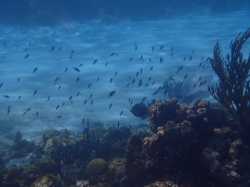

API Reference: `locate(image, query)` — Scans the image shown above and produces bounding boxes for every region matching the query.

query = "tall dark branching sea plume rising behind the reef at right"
[208,28,250,129]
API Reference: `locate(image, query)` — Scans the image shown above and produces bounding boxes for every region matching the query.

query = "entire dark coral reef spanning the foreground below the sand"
[0,98,250,187]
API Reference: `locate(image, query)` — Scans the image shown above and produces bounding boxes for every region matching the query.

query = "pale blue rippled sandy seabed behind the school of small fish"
[0,12,250,143]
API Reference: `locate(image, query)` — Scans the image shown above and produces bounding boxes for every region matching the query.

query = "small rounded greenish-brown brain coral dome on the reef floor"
[86,158,108,176]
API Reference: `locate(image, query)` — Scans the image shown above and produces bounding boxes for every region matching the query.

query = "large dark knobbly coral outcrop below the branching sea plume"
[126,98,250,186]
